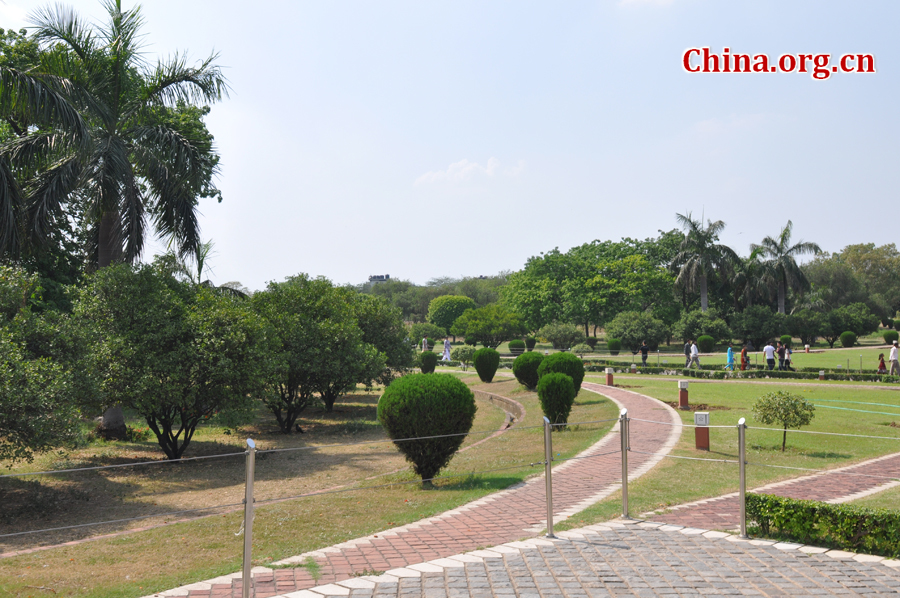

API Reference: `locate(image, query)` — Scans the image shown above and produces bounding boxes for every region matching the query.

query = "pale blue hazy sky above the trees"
[0,0,900,290]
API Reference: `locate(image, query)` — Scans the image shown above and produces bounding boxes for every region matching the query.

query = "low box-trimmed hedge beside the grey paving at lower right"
[746,494,900,558]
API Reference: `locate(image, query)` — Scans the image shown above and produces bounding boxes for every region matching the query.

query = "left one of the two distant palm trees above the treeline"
[672,212,740,311]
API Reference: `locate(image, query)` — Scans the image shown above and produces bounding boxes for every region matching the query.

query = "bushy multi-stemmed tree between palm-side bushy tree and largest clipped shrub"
[251,274,384,422]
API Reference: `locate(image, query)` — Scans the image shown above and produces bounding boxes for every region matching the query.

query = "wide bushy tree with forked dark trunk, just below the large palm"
[74,265,268,459]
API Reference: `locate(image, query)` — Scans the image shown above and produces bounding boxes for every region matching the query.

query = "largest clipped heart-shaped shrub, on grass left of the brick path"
[378,374,476,486]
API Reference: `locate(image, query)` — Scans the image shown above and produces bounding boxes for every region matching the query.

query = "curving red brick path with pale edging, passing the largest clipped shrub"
[149,383,681,598]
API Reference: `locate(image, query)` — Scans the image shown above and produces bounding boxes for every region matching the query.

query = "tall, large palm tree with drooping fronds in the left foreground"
[0,0,228,267]
